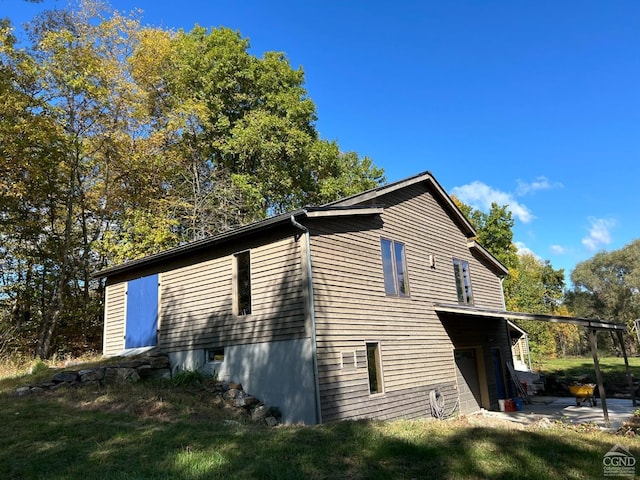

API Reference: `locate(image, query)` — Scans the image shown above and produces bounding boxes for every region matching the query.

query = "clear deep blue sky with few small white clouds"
[0,0,640,282]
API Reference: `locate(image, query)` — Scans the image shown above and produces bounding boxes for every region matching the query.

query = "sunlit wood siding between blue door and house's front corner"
[159,237,307,352]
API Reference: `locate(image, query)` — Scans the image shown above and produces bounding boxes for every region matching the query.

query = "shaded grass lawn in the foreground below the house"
[0,358,640,480]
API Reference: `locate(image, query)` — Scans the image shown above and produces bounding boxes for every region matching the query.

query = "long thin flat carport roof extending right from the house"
[434,303,627,332]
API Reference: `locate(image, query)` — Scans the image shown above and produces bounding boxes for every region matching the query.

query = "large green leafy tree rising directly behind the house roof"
[133,26,384,241]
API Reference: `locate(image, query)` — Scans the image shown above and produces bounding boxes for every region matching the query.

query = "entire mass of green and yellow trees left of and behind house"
[0,0,384,357]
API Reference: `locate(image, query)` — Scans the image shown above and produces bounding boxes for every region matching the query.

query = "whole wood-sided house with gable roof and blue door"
[97,172,524,424]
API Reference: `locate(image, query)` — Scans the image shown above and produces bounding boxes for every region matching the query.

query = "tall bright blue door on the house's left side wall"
[124,275,158,348]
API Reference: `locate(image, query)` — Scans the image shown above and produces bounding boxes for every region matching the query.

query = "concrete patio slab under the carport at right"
[482,396,640,430]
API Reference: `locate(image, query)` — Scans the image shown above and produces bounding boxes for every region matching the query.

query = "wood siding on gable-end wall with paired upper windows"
[310,180,510,421]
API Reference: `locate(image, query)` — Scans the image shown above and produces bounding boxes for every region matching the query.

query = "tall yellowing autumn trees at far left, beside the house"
[0,2,151,357]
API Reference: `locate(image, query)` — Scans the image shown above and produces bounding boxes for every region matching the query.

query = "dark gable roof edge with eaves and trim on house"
[93,171,509,278]
